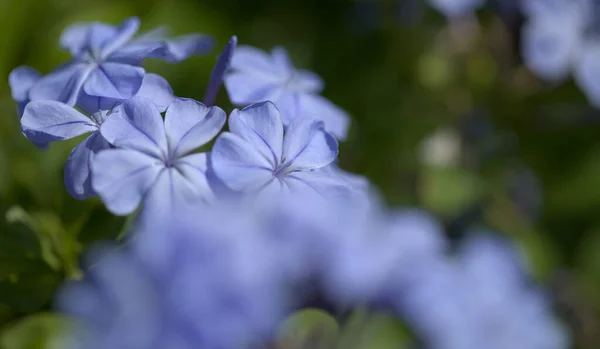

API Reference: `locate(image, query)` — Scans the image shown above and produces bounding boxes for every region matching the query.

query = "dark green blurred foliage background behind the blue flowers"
[0,0,600,348]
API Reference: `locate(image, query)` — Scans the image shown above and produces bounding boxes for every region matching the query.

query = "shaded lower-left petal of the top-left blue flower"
[29,62,94,105]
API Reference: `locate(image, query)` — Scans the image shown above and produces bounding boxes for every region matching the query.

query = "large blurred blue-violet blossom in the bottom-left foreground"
[56,207,289,349]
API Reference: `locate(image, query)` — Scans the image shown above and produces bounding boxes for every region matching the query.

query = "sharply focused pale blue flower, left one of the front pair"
[91,96,226,215]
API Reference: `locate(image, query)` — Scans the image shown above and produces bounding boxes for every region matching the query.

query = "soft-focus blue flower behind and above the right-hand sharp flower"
[225,46,350,140]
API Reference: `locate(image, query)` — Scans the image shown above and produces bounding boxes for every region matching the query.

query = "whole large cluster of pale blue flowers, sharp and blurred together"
[9,18,568,349]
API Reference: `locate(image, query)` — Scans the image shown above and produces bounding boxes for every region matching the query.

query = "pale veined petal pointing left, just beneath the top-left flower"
[21,101,98,143]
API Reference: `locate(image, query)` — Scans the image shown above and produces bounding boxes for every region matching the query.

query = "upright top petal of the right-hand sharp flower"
[229,102,283,168]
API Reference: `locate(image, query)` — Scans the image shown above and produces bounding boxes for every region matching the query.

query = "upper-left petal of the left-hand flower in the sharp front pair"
[100,96,168,159]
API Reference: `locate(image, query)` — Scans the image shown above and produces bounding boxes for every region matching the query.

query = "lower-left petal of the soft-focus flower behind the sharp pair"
[224,70,282,106]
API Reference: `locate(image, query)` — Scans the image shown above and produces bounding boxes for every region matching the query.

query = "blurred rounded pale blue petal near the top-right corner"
[521,19,581,80]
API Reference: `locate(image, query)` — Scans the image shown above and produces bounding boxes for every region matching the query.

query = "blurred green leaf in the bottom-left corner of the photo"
[0,313,72,349]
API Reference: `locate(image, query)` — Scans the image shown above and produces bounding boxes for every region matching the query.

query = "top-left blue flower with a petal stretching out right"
[23,17,213,106]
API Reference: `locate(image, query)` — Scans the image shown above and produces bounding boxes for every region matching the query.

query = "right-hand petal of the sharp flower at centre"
[283,118,338,171]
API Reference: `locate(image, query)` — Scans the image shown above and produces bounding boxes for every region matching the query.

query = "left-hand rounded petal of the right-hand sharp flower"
[210,132,273,191]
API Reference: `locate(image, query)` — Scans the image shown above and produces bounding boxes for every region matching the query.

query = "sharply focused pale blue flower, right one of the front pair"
[211,102,348,196]
